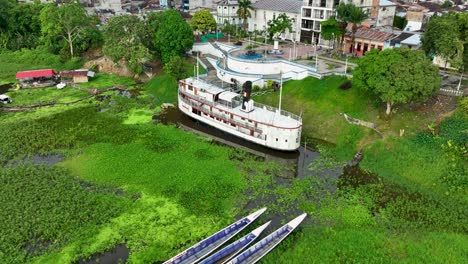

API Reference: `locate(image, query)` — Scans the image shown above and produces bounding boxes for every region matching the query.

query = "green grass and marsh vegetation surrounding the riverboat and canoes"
[0,50,468,264]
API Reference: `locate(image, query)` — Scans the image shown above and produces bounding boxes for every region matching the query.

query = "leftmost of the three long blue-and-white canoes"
[164,208,266,264]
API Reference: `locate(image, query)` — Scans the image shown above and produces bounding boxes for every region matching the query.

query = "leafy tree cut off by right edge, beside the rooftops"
[422,13,468,69]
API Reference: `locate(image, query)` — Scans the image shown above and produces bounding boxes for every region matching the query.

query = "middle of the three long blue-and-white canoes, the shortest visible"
[200,221,271,264]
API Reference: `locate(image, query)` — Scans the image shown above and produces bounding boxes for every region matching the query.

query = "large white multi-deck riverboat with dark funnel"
[178,77,302,151]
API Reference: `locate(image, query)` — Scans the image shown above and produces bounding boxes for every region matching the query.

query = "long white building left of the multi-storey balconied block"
[247,0,302,41]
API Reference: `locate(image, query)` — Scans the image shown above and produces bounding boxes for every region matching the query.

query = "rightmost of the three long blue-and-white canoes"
[228,213,307,264]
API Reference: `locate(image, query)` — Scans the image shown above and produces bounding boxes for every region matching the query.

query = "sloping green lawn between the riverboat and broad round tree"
[254,76,378,143]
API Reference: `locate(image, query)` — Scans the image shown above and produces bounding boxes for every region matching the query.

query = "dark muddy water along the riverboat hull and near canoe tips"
[153,108,342,234]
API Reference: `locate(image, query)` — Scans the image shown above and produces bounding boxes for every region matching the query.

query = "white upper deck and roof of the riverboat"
[179,78,302,129]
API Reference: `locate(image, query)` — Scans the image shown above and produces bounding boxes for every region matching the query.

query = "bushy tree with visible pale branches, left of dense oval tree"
[103,15,150,73]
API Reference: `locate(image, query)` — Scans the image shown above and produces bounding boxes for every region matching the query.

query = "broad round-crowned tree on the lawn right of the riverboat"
[353,48,441,115]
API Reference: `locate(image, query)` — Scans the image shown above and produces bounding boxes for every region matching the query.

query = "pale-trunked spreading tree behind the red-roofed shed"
[40,3,95,57]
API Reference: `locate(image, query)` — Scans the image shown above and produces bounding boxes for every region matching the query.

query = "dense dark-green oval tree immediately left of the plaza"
[154,9,193,63]
